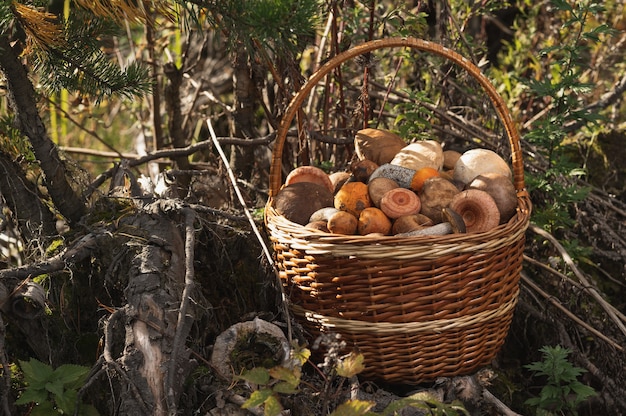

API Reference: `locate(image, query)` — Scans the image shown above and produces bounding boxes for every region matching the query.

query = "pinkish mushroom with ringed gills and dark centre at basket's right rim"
[449,189,500,233]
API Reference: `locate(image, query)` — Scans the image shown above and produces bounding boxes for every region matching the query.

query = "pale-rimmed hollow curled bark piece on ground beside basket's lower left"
[211,318,290,381]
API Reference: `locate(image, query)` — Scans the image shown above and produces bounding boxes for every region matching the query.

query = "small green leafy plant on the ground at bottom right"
[525,345,596,415]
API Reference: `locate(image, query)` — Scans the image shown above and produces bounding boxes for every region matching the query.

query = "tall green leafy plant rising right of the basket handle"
[522,0,614,232]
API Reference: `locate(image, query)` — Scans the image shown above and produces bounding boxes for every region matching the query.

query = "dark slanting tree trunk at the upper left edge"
[0,36,85,224]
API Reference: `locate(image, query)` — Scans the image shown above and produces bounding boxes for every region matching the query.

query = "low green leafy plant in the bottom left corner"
[15,358,98,416]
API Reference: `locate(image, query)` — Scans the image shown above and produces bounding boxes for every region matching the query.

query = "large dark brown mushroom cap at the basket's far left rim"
[273,182,333,225]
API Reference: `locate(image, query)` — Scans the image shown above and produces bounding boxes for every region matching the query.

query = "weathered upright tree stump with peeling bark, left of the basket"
[113,204,195,416]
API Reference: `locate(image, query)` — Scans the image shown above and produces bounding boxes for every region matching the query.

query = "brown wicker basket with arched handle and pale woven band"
[265,38,531,384]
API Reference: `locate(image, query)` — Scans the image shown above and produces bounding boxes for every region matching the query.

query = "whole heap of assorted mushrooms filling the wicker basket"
[274,128,517,236]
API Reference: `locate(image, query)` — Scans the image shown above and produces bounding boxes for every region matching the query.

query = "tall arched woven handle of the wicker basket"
[269,37,528,199]
